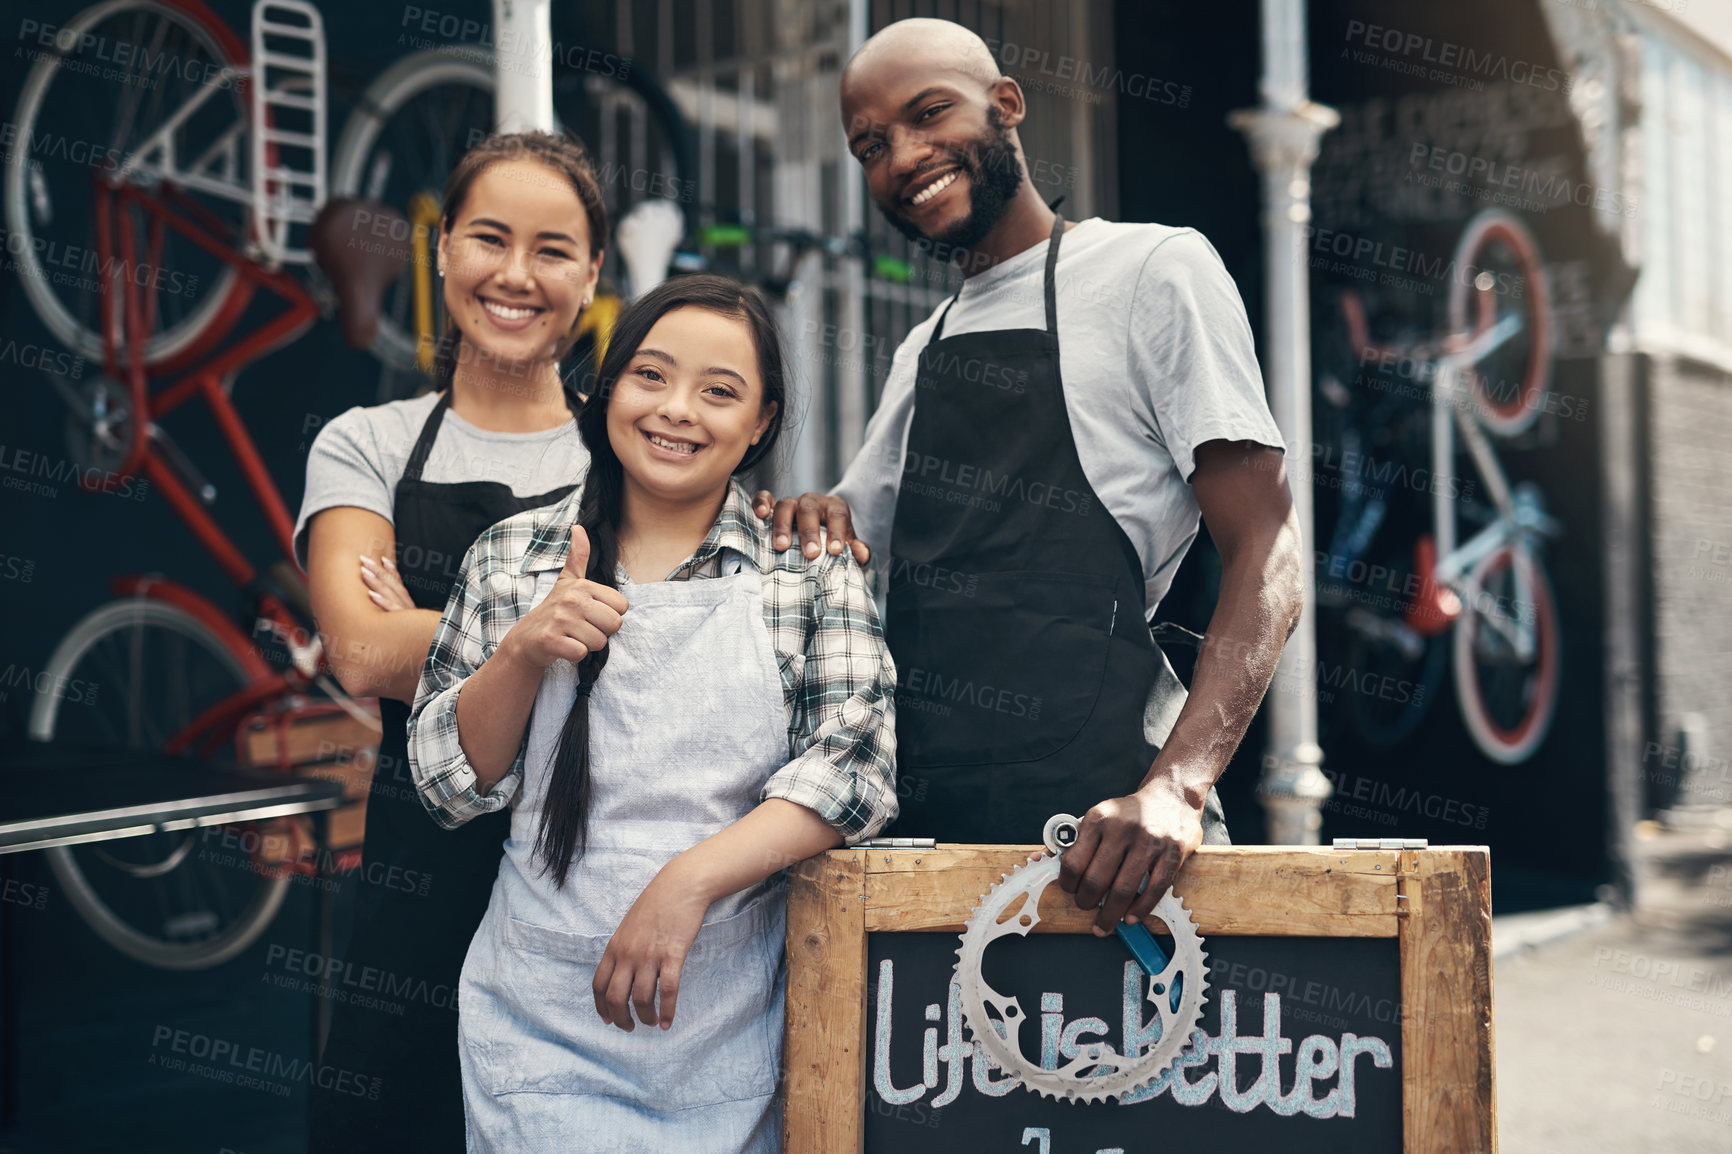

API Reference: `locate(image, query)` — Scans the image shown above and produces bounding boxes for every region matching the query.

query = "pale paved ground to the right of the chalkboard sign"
[1493,813,1732,1154]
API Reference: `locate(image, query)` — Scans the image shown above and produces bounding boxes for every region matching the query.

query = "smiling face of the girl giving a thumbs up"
[608,307,776,502]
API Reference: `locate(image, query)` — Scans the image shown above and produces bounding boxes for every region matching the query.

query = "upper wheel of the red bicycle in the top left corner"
[5,0,249,364]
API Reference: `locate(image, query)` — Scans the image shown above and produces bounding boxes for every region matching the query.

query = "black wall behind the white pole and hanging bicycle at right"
[1115,0,1628,908]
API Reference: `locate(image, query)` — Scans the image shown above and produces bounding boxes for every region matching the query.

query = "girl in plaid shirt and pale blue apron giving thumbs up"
[409,276,897,1152]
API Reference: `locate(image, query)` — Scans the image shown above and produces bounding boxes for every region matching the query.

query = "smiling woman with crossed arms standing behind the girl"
[296,133,608,1154]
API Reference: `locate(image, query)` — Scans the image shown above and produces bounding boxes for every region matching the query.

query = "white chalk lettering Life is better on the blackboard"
[873,958,1394,1118]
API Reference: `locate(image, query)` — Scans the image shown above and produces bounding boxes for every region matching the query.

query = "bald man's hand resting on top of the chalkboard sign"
[1058,778,1202,937]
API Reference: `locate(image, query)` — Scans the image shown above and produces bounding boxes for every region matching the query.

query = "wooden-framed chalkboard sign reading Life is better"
[785,846,1493,1154]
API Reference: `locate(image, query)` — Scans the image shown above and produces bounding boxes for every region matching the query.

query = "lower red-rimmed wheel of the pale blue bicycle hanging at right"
[1455,546,1561,766]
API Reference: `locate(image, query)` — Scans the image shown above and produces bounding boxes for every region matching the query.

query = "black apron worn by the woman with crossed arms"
[308,390,575,1154]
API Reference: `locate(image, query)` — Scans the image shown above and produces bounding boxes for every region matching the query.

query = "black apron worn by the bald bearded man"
[885,217,1228,844]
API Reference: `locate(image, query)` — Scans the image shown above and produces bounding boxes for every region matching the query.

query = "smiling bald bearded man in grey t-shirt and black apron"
[759,19,1302,934]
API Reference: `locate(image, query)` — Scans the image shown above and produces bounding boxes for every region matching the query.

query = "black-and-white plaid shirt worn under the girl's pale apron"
[409,482,897,846]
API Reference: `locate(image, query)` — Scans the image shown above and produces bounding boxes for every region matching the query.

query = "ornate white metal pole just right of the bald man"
[1228,0,1341,846]
